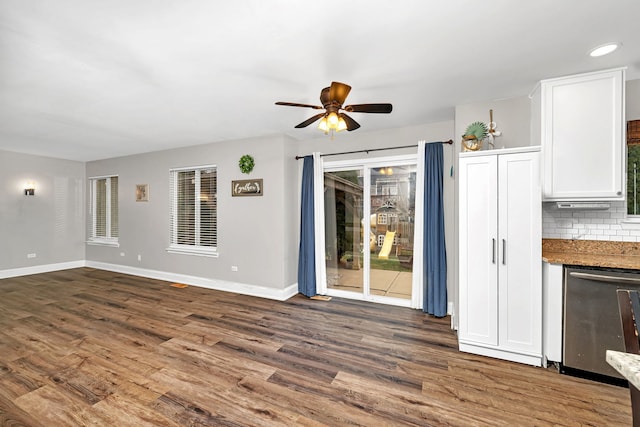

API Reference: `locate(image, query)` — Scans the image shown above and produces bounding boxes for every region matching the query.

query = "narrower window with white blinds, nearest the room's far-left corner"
[89,176,119,245]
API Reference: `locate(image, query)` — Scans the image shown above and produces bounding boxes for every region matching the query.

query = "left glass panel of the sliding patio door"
[324,169,364,294]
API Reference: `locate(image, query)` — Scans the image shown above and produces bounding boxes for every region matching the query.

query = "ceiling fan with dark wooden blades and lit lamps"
[276,82,393,133]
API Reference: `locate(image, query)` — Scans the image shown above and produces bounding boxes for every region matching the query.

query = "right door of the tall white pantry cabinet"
[498,153,542,356]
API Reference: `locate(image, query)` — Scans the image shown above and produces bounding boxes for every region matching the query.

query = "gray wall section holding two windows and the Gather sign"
[86,136,297,289]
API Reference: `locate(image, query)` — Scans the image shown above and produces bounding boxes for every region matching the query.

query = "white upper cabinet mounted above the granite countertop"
[532,68,626,201]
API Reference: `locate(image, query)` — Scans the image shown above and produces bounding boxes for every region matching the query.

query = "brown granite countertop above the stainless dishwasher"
[542,239,640,270]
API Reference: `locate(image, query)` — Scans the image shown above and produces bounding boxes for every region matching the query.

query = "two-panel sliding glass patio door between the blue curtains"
[324,162,416,306]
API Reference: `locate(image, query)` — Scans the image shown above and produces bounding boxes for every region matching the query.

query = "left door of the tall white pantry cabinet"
[458,156,498,346]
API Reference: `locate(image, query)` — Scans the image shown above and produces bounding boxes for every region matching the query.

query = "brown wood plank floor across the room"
[0,268,631,427]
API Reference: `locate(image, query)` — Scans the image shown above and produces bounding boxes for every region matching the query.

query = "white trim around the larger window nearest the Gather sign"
[166,164,220,258]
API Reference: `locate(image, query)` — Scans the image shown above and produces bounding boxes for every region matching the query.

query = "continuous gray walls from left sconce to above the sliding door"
[0,121,456,306]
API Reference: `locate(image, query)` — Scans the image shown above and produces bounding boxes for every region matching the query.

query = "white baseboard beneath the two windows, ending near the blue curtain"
[86,261,298,301]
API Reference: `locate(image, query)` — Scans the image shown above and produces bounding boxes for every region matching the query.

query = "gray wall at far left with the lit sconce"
[0,150,86,270]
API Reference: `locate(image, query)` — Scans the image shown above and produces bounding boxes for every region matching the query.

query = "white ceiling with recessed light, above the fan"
[0,0,640,161]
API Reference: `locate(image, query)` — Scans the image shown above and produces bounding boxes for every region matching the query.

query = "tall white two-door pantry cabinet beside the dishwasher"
[458,147,542,366]
